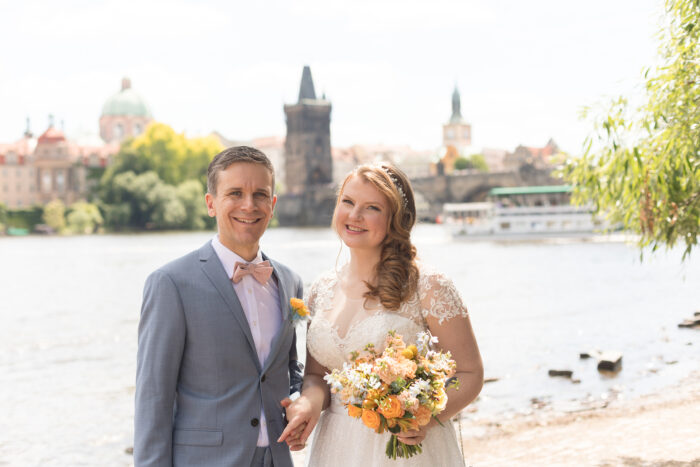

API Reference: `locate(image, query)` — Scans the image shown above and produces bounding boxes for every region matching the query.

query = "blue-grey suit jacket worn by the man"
[134,242,303,467]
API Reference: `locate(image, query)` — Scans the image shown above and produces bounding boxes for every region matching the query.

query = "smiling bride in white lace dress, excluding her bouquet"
[279,164,483,467]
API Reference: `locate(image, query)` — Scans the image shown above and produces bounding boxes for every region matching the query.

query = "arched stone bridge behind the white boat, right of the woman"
[411,165,562,219]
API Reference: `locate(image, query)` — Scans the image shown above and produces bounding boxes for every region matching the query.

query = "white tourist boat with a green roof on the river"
[442,185,607,238]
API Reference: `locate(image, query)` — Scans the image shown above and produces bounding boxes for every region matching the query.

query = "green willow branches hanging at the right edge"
[563,0,700,259]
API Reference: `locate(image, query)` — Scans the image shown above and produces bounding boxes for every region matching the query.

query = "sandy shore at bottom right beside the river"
[293,372,700,467]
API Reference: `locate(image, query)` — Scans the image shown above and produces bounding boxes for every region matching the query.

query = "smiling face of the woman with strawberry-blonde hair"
[334,175,390,254]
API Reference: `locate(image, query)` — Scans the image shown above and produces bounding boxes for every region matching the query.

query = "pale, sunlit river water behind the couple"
[0,225,700,466]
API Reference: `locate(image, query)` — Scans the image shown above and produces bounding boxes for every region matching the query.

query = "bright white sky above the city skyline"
[0,0,663,154]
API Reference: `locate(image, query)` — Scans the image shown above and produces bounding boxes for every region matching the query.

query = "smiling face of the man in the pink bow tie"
[206,162,277,261]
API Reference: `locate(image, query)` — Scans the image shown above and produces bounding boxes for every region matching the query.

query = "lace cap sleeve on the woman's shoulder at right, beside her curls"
[418,270,468,324]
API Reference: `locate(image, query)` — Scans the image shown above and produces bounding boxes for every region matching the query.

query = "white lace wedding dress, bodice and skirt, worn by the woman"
[306,265,467,467]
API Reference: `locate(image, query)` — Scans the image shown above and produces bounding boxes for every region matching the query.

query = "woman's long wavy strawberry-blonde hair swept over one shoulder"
[332,162,418,310]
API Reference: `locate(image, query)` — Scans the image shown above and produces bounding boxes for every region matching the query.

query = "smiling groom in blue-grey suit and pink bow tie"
[134,146,302,467]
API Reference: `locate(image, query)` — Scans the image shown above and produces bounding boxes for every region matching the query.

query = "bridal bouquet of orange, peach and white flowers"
[324,331,458,459]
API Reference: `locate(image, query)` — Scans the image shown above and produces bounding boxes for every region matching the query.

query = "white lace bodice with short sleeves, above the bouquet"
[306,264,467,370]
